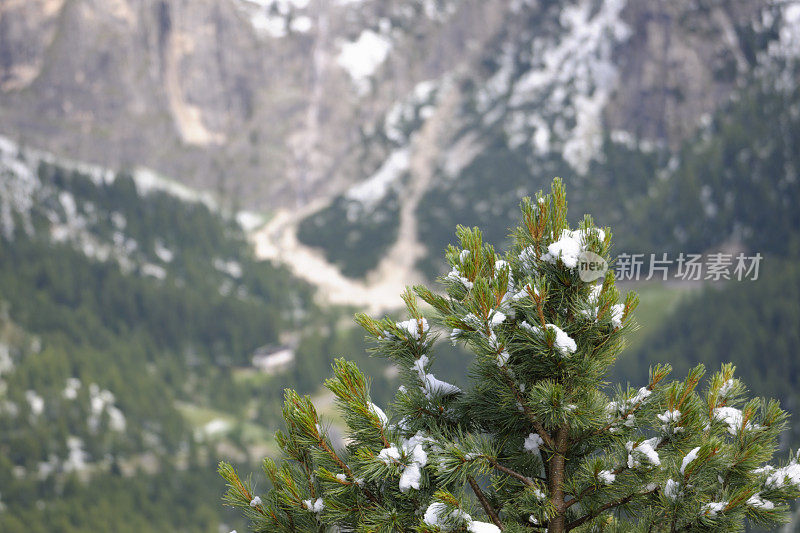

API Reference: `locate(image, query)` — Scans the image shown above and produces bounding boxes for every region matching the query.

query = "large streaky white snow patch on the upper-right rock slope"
[494,0,631,174]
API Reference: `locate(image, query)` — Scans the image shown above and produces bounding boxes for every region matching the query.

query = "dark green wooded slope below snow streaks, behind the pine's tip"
[416,130,664,278]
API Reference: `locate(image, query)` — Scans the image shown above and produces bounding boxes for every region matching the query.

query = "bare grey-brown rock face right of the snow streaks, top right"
[607,0,764,146]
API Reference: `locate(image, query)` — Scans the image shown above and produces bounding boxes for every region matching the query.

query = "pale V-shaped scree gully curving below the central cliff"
[253,86,457,313]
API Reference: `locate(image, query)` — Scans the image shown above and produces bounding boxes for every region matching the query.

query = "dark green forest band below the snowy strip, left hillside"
[0,239,288,364]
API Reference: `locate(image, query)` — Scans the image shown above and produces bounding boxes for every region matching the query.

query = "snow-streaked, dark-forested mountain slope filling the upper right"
[288,2,800,279]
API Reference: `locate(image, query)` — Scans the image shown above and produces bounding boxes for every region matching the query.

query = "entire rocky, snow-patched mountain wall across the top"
[0,0,800,288]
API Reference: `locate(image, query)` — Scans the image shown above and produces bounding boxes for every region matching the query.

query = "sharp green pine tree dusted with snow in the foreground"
[220,180,800,533]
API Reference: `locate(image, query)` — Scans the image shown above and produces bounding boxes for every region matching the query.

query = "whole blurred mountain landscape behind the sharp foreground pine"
[0,0,800,531]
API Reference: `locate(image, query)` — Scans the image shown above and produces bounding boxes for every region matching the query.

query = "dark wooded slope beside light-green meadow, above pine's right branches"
[615,256,800,440]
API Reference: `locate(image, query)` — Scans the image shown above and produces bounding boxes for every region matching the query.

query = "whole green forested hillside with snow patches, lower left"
[0,138,322,532]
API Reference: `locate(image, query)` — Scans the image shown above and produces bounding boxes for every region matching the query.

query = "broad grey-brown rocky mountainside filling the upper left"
[0,0,501,209]
